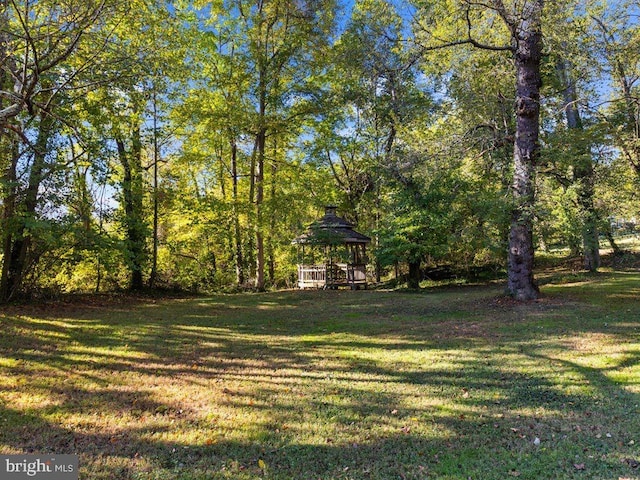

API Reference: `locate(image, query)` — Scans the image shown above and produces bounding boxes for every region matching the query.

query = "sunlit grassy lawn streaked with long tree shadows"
[0,271,640,480]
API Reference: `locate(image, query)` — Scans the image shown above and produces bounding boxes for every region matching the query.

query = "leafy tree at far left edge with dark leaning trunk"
[0,0,111,301]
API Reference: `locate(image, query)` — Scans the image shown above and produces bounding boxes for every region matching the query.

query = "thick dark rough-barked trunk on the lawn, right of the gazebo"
[507,0,543,300]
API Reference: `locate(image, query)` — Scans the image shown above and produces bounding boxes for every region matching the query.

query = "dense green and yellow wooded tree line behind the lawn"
[0,0,640,301]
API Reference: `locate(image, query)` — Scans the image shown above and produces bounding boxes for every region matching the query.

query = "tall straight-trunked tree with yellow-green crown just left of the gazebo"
[238,0,334,290]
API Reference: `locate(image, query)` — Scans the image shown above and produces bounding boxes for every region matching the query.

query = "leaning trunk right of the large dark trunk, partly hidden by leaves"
[557,60,600,272]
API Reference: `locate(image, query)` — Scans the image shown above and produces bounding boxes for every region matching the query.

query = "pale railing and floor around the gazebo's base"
[298,263,367,289]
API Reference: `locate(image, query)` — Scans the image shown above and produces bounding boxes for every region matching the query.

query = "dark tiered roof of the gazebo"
[291,206,371,245]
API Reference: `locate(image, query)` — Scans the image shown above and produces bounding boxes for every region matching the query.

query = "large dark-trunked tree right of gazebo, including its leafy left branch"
[417,0,544,300]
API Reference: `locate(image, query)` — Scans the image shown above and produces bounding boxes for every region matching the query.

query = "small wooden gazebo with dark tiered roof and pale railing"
[291,206,371,289]
